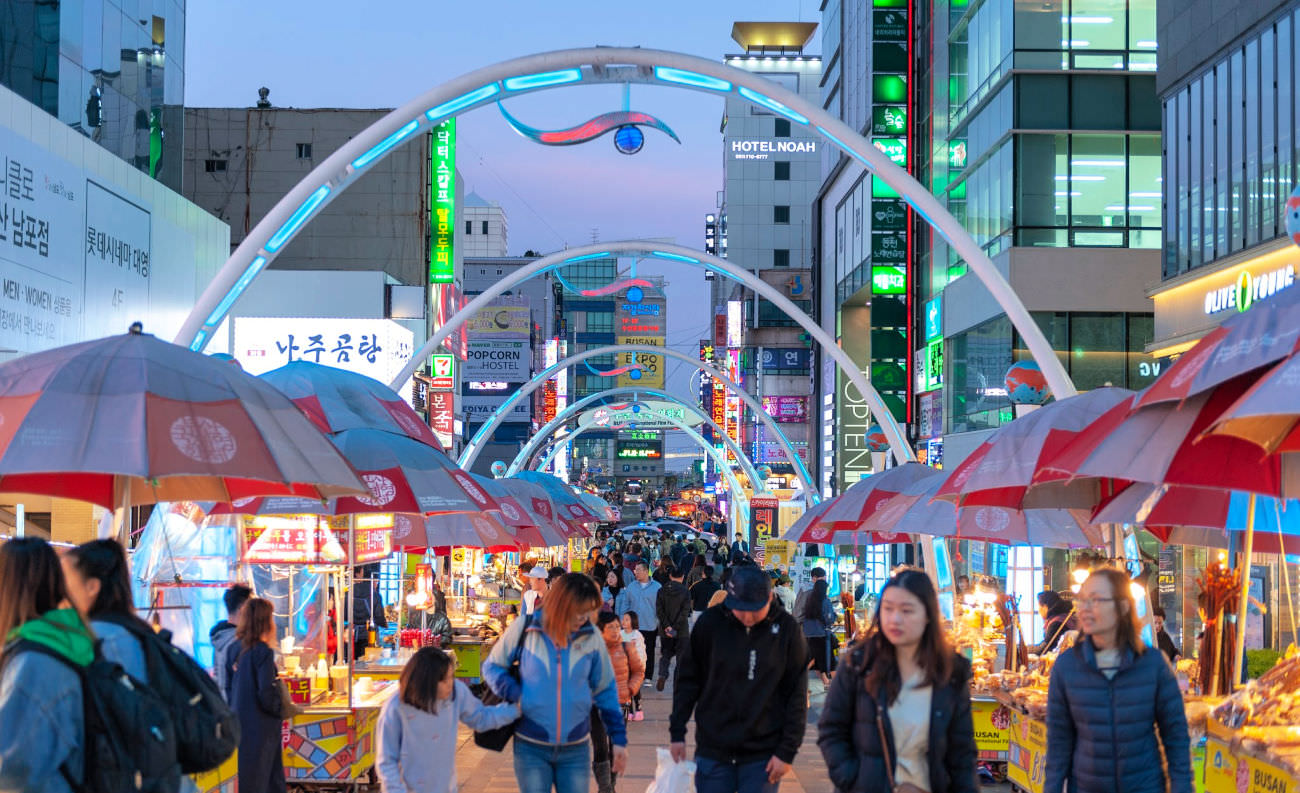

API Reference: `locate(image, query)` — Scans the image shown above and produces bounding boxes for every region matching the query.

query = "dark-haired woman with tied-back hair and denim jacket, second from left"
[62,540,152,683]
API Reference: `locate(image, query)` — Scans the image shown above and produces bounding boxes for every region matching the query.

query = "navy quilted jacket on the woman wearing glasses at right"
[1043,640,1192,793]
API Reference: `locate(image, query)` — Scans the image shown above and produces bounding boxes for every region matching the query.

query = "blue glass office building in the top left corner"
[0,0,185,191]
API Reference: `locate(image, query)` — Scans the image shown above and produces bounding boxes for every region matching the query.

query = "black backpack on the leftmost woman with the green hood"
[4,640,181,793]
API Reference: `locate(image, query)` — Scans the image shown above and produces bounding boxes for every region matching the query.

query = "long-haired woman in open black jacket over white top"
[818,568,977,793]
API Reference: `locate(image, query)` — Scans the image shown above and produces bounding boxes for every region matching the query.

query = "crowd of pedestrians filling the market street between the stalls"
[0,534,1192,793]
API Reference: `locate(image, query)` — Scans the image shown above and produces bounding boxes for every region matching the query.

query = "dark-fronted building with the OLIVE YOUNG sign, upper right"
[1151,0,1300,356]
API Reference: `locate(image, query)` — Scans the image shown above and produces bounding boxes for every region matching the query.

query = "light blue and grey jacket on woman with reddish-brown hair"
[482,607,628,746]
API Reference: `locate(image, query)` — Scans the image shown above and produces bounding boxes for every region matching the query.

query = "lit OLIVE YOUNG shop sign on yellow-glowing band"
[1147,237,1300,356]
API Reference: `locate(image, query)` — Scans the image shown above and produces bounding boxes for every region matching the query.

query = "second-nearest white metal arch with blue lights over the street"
[405,241,917,464]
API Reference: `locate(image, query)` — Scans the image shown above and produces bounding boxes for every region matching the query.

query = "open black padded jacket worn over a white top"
[816,645,972,793]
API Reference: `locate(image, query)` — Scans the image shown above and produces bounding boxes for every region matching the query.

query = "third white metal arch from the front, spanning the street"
[457,345,816,490]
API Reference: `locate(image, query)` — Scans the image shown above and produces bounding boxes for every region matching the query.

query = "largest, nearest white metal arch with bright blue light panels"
[176,47,1076,462]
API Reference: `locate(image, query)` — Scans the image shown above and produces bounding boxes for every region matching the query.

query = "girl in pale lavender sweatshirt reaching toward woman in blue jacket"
[374,647,519,793]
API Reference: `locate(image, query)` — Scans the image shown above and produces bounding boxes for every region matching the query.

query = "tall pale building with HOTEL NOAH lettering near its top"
[705,22,823,493]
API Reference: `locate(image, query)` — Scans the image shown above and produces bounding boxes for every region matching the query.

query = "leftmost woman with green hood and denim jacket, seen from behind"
[0,538,95,793]
